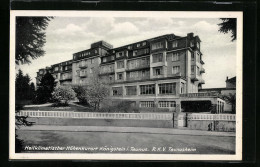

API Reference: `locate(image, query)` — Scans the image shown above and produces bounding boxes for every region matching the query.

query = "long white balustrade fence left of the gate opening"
[16,111,173,120]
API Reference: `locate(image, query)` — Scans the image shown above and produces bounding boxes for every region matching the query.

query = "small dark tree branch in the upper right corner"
[218,18,237,41]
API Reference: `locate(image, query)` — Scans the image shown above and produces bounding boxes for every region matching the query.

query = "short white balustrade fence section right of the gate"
[188,114,236,121]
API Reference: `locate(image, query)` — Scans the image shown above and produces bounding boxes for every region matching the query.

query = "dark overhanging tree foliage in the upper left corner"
[15,17,53,64]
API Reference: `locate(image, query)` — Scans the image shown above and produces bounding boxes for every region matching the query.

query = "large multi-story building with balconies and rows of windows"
[36,33,224,112]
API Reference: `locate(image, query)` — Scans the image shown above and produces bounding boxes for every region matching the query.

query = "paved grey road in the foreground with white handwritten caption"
[17,125,235,154]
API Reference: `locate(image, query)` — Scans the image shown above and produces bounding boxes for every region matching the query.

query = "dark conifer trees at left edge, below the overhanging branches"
[15,70,35,102]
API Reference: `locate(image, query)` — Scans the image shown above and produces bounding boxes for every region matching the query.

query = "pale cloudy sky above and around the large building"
[16,17,236,88]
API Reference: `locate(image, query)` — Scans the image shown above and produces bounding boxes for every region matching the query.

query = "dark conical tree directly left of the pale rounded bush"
[35,72,56,103]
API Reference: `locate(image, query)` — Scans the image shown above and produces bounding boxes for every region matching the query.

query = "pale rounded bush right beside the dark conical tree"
[52,86,76,106]
